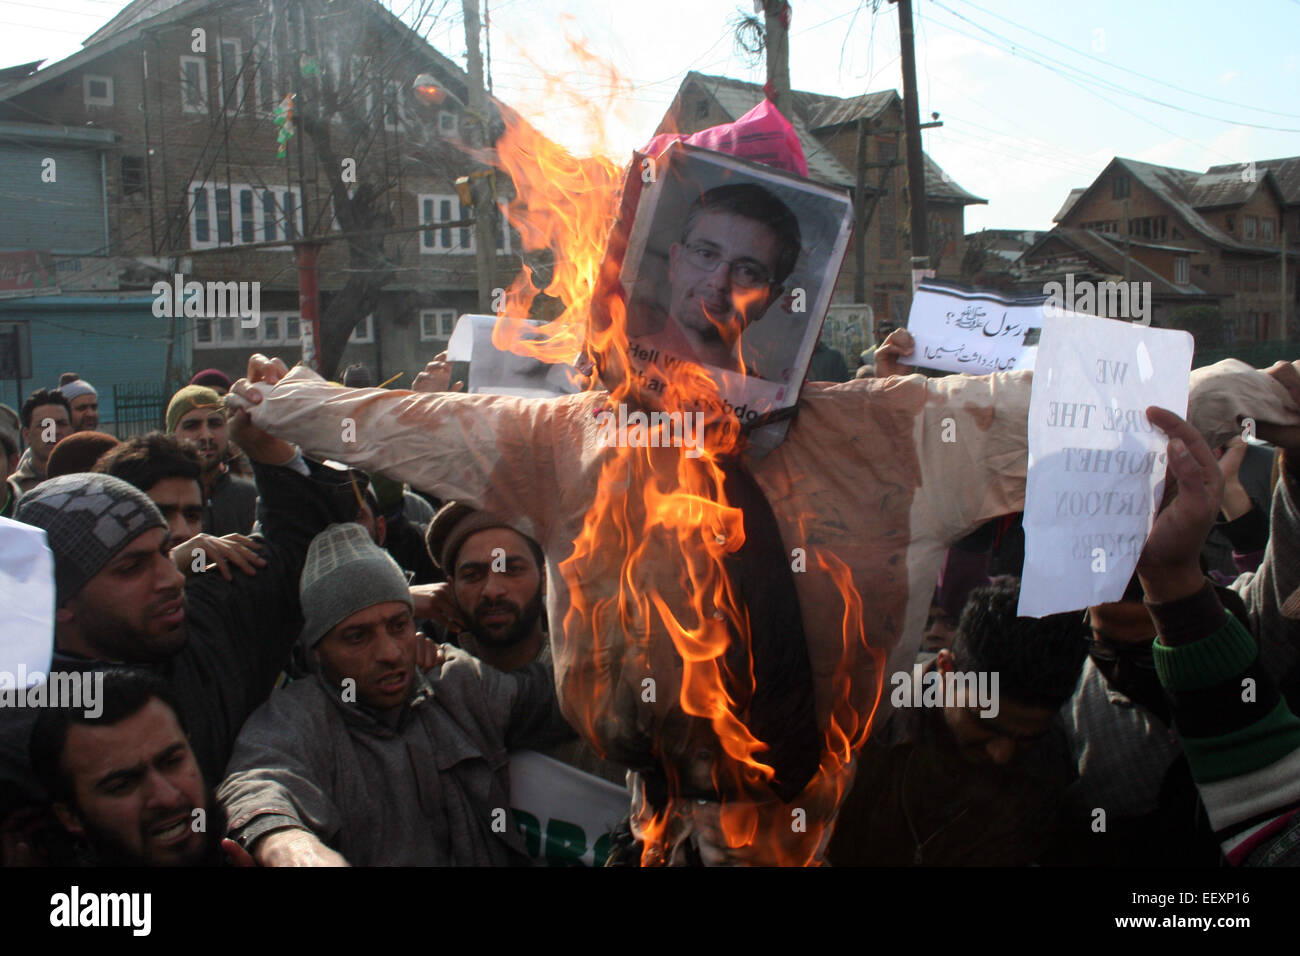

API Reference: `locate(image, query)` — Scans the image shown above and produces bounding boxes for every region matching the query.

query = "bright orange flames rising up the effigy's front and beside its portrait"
[467,40,884,864]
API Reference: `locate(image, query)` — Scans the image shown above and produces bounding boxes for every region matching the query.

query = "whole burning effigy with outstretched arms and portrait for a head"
[228,74,1300,865]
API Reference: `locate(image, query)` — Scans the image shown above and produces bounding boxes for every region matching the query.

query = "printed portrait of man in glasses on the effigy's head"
[624,149,842,384]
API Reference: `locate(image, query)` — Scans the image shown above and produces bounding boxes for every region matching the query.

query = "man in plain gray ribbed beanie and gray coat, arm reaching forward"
[218,524,573,866]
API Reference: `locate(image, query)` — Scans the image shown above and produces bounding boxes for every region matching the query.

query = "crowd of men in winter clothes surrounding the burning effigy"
[0,332,1300,866]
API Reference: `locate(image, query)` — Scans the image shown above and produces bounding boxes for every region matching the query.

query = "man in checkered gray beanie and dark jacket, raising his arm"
[0,403,355,832]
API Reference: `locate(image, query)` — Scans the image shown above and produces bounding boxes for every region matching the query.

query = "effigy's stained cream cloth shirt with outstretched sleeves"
[235,360,1300,861]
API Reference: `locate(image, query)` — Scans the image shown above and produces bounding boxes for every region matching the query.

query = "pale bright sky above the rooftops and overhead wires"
[0,0,1300,232]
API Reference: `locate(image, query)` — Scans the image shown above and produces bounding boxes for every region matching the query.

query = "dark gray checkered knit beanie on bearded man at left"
[13,472,166,607]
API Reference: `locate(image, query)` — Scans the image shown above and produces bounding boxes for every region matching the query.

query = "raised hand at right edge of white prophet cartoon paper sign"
[1138,406,1223,604]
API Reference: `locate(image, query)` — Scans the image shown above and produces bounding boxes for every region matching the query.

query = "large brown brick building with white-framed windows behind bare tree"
[0,0,520,403]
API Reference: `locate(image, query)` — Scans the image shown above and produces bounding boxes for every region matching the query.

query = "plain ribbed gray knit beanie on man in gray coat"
[299,524,413,649]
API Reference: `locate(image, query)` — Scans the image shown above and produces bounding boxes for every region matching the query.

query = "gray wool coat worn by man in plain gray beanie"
[217,645,573,866]
